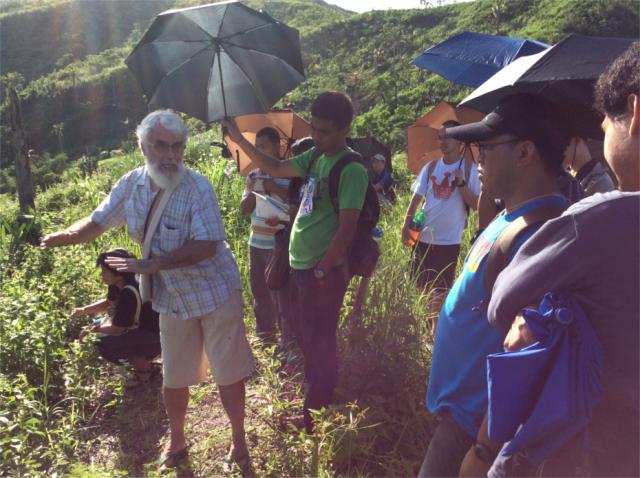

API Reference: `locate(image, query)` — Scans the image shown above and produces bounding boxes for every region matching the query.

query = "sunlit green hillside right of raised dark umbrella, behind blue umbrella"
[289,0,640,149]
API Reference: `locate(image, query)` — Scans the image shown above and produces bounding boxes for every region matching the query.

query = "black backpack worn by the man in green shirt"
[329,152,380,277]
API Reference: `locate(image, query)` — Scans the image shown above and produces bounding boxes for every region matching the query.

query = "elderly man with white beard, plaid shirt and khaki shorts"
[41,110,254,468]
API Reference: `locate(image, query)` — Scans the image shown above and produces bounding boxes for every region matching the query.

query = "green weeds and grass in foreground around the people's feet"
[0,133,476,476]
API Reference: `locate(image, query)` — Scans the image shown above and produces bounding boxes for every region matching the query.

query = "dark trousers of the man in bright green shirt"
[291,267,348,431]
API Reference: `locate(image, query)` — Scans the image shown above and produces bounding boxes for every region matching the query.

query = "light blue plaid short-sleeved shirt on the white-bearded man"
[91,166,241,319]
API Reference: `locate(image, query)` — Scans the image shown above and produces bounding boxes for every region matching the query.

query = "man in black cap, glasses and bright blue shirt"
[419,95,568,476]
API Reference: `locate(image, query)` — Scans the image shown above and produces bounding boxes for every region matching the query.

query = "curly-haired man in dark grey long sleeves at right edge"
[488,42,640,476]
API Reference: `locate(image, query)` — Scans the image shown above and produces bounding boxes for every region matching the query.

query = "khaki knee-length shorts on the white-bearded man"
[160,291,255,388]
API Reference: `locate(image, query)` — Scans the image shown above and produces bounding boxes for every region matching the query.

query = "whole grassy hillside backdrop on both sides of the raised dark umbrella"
[0,0,640,195]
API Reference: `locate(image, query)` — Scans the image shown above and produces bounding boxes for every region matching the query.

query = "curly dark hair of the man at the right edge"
[595,42,640,116]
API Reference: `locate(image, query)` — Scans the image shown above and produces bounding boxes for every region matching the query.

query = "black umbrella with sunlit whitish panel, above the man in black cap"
[460,35,634,139]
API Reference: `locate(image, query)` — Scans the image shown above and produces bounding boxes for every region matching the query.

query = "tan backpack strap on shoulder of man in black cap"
[484,205,564,295]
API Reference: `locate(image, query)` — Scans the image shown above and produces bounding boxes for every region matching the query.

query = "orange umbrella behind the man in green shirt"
[224,109,311,176]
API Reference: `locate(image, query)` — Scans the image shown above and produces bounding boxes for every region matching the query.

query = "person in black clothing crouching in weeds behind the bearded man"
[71,249,160,373]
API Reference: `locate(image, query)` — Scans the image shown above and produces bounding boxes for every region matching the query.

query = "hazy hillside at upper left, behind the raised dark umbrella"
[0,0,350,194]
